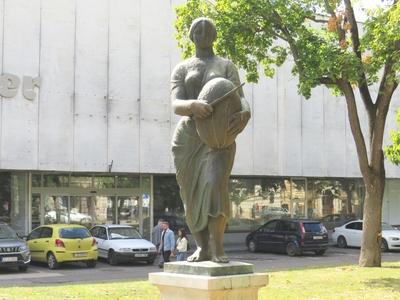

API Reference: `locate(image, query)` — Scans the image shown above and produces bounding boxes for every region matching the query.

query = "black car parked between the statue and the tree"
[246,219,328,256]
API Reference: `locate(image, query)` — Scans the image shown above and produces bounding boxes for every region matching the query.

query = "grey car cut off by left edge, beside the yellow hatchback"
[0,223,31,271]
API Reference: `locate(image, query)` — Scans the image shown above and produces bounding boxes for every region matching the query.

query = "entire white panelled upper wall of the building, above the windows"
[0,0,400,177]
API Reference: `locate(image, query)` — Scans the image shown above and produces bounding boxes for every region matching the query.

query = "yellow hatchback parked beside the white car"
[27,224,97,269]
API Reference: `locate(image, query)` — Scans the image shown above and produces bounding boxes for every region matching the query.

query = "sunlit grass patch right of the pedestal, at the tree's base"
[259,262,400,300]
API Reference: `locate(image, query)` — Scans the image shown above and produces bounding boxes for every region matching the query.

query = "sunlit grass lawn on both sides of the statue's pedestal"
[0,262,400,300]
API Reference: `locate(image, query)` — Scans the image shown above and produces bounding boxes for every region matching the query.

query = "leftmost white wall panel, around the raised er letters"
[1,0,40,169]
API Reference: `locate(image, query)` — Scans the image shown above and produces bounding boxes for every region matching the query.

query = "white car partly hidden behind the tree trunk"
[332,220,400,251]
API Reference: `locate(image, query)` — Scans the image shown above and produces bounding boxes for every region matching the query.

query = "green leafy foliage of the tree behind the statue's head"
[175,0,400,98]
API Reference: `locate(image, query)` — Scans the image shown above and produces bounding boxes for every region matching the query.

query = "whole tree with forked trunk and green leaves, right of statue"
[175,0,400,267]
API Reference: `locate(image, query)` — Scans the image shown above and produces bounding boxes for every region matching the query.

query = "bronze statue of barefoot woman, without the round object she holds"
[171,18,250,263]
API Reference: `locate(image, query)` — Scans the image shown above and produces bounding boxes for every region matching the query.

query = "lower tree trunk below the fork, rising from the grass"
[359,174,385,267]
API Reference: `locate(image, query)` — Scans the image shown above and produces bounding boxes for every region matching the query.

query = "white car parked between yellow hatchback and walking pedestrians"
[90,225,157,265]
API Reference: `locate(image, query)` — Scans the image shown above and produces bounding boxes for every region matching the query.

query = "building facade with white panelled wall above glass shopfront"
[0,0,400,237]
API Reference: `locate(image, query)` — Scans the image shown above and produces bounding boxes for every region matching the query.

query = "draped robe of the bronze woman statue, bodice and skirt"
[171,56,243,233]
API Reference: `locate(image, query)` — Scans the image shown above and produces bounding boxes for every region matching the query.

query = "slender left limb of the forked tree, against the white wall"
[338,79,370,178]
